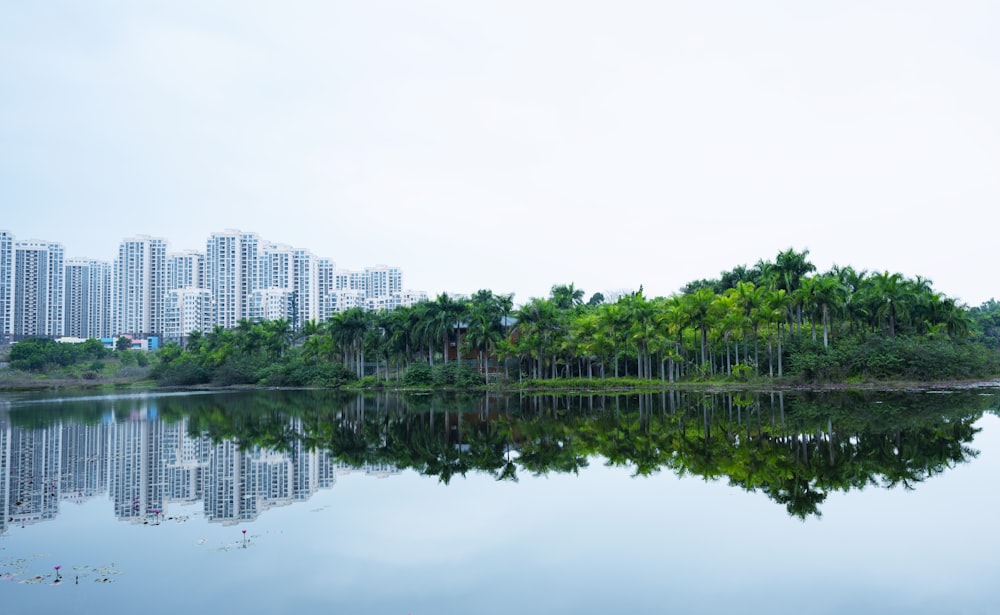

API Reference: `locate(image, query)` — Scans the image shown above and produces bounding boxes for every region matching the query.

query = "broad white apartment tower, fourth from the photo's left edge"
[111,235,167,337]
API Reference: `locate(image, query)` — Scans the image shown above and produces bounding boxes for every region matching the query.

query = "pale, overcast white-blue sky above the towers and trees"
[0,0,1000,306]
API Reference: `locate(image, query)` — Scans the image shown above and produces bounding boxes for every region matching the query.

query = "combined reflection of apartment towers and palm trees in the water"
[0,391,997,532]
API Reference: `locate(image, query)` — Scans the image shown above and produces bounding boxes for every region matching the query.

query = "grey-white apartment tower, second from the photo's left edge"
[11,240,63,339]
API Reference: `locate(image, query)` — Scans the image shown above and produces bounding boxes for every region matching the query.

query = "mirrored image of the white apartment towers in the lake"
[0,405,398,534]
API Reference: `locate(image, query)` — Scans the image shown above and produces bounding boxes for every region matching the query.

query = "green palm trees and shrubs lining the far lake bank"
[146,249,1000,385]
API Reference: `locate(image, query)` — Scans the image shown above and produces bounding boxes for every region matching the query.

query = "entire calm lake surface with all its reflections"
[0,389,1000,615]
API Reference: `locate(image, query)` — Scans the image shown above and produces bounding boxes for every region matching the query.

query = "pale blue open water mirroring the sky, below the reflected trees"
[0,415,1000,615]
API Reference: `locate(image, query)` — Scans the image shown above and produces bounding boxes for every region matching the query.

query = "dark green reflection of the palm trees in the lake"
[11,391,997,519]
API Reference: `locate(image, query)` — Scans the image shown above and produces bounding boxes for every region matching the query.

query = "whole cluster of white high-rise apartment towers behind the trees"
[0,229,427,349]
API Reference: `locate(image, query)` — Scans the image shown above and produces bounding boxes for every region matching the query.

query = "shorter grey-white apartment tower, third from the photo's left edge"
[63,258,111,339]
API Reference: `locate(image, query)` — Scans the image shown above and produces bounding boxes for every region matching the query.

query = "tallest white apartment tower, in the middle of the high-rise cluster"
[205,230,261,329]
